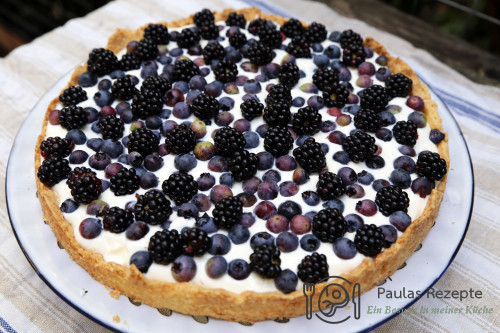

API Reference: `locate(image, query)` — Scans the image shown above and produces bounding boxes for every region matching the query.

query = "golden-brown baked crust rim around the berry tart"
[35,8,450,322]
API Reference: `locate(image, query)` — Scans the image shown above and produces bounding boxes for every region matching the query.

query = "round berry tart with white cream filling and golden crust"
[35,8,449,322]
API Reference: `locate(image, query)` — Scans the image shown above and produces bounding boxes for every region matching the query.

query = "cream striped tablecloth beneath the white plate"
[0,0,500,333]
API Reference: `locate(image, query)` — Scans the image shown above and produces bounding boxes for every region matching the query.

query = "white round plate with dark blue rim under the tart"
[6,70,474,333]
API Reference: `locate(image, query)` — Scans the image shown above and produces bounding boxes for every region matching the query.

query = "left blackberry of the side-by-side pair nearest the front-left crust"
[148,229,182,265]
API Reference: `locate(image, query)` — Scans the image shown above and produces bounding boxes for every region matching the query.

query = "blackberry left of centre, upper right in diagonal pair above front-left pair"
[161,173,198,205]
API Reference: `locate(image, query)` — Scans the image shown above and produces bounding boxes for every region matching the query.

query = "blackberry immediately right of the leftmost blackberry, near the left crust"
[66,167,102,204]
